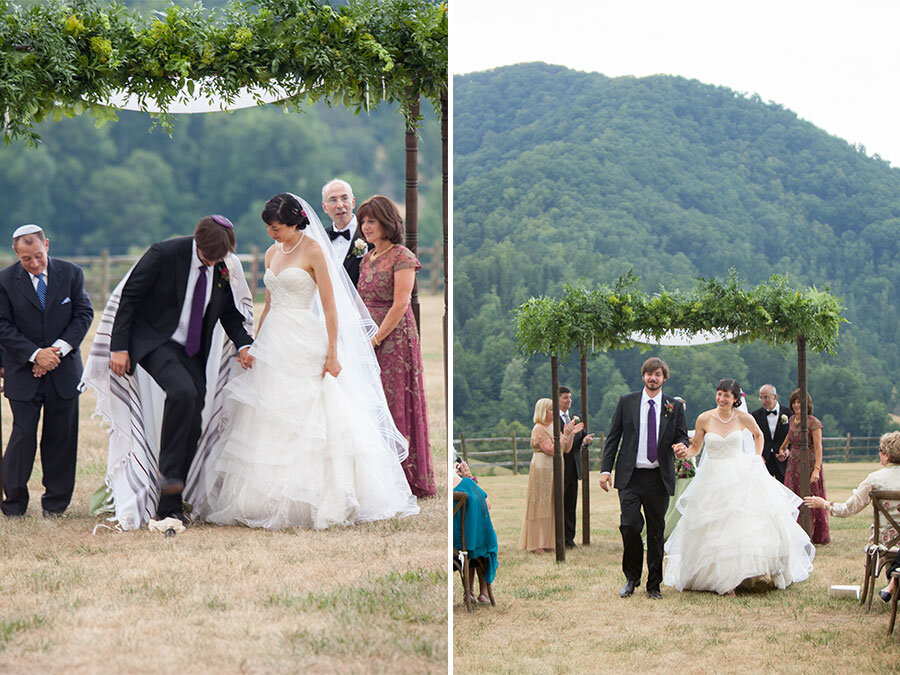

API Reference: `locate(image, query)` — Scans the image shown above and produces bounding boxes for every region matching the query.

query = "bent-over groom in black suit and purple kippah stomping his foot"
[109,216,253,520]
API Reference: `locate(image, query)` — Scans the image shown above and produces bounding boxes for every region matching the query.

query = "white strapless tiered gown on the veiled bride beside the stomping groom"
[200,267,419,529]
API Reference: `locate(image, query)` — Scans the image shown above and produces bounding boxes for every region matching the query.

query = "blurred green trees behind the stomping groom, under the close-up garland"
[0,0,442,255]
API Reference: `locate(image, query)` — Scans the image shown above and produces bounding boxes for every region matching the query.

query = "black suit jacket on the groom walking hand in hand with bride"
[600,390,689,495]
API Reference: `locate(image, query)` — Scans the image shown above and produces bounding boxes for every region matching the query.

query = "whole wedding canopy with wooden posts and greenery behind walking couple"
[516,270,846,562]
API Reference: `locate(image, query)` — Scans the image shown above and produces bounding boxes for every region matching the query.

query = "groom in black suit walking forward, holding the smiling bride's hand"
[600,357,689,600]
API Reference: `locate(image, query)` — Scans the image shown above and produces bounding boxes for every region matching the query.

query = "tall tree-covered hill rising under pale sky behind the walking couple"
[453,64,900,436]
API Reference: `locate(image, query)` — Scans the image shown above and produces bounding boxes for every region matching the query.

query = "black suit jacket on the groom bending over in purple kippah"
[110,237,253,371]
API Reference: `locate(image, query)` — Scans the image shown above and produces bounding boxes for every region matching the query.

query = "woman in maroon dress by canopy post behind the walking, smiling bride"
[778,389,831,544]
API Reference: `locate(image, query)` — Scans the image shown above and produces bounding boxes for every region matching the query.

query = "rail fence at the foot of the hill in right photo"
[453,434,881,474]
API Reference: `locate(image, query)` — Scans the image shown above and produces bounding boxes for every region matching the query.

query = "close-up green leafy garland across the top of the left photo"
[0,0,447,144]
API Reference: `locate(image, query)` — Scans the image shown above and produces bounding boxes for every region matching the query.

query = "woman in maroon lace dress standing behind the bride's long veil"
[356,195,437,497]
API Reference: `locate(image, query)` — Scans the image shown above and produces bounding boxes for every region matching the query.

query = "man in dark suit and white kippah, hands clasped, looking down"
[0,225,94,518]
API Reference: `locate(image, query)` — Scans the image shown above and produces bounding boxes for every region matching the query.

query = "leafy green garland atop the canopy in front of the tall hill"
[516,270,846,362]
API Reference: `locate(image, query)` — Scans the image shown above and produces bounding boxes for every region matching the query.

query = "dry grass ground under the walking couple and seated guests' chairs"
[452,464,900,673]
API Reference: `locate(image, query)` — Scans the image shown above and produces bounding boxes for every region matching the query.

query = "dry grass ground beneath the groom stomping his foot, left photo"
[0,296,448,673]
